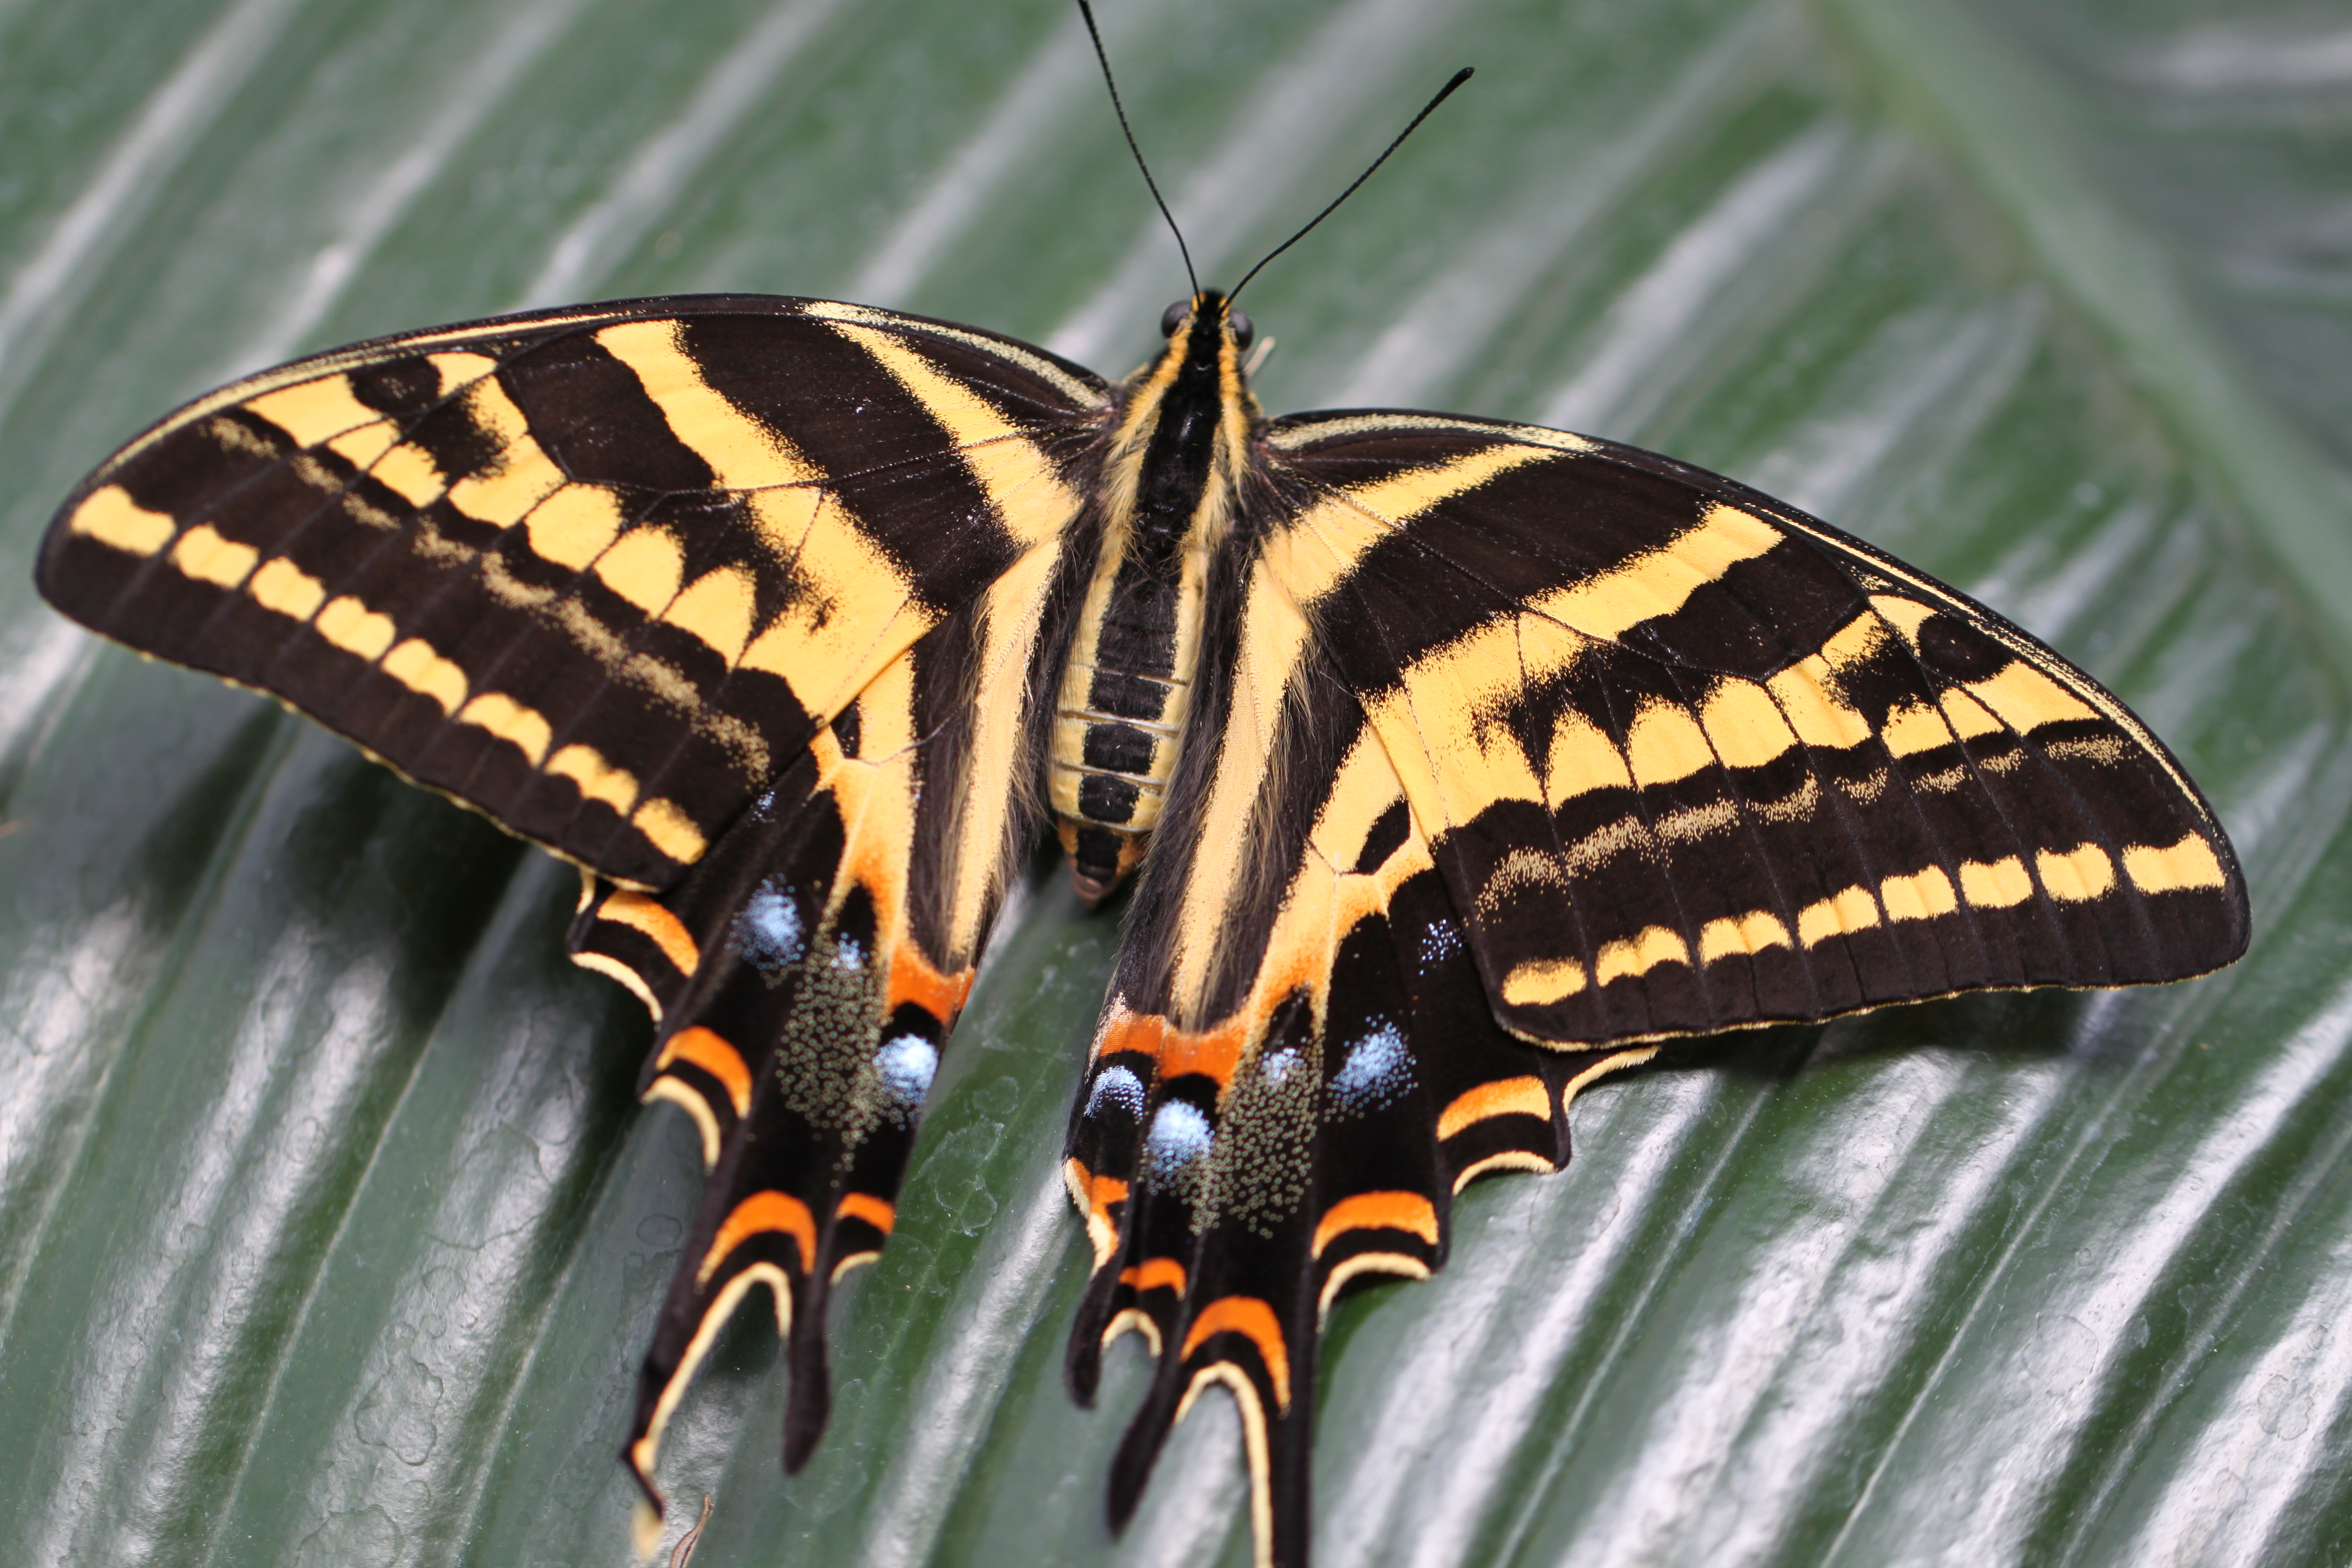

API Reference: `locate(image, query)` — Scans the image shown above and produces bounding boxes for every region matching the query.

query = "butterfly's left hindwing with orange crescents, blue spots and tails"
[572,545,1068,1500]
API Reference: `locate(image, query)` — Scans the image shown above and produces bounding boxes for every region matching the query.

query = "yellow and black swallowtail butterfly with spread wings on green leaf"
[38,21,2249,1568]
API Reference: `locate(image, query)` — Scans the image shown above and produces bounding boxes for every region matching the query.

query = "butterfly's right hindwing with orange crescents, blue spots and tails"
[1063,552,1651,1564]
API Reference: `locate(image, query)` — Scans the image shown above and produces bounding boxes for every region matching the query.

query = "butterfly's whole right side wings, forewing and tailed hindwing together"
[1066,414,2246,1564]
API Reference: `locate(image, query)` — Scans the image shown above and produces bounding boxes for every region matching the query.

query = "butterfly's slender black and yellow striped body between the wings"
[1047,292,1261,903]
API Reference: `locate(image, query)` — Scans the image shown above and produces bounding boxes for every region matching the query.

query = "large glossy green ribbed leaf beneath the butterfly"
[0,0,2352,1568]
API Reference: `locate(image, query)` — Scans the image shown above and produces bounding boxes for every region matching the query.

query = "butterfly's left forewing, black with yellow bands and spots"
[38,296,1108,888]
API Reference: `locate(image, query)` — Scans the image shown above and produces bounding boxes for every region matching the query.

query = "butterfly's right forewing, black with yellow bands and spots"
[1263,414,2249,1044]
